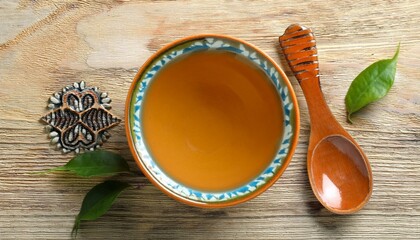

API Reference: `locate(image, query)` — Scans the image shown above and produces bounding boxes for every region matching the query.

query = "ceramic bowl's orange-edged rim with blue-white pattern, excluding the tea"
[125,35,299,208]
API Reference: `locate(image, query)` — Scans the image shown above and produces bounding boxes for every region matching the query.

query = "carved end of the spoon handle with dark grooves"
[279,24,319,84]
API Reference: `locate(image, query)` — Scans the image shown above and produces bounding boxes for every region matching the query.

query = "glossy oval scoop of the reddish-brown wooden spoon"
[308,135,370,213]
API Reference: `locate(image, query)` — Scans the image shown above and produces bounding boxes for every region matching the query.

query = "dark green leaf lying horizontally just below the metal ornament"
[48,150,130,177]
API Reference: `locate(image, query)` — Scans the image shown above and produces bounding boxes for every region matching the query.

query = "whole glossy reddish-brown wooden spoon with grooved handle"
[279,24,372,214]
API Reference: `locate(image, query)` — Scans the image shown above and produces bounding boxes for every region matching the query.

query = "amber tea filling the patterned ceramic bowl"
[141,50,283,192]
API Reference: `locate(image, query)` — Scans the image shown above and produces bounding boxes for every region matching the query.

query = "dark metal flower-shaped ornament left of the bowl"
[41,81,121,153]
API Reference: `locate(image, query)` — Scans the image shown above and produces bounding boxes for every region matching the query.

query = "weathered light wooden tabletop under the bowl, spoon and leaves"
[0,0,420,239]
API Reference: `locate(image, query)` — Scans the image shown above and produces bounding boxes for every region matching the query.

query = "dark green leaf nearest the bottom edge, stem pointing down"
[71,180,130,237]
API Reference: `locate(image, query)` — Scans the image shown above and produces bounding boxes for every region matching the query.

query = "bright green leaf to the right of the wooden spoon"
[345,44,400,123]
